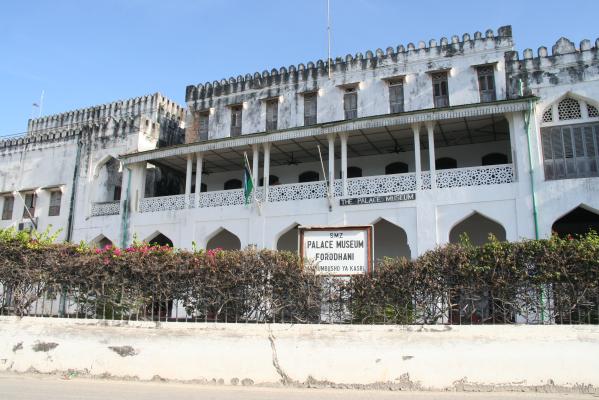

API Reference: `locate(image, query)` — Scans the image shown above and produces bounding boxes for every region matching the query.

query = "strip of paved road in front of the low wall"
[0,374,599,400]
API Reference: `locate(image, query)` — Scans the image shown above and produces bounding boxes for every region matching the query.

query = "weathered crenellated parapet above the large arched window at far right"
[505,37,599,98]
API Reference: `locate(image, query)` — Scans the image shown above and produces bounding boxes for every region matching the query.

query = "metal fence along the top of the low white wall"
[0,278,599,325]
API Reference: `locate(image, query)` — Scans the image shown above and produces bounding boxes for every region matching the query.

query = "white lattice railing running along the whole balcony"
[103,164,514,215]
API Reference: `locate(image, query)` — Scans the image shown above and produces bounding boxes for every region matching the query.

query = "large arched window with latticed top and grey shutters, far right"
[541,96,599,180]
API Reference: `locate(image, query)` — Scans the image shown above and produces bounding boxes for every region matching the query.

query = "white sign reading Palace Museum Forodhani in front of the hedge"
[298,225,372,276]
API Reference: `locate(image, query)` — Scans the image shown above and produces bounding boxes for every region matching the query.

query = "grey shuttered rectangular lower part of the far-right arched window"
[541,123,599,180]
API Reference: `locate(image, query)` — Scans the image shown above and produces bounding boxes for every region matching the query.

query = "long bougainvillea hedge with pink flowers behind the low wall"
[0,229,599,324]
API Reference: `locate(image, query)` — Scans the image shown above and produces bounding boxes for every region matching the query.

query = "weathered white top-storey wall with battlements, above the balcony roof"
[186,26,513,142]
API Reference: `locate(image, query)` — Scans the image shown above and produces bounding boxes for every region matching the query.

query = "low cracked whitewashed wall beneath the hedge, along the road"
[0,317,599,389]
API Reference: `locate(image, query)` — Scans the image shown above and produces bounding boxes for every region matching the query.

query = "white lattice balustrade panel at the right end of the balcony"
[436,164,514,188]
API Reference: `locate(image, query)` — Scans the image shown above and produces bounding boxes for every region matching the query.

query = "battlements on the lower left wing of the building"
[27,93,185,136]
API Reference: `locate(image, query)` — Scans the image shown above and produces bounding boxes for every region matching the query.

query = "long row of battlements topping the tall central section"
[185,25,512,102]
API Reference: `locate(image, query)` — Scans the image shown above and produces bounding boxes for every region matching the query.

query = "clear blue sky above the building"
[0,0,599,136]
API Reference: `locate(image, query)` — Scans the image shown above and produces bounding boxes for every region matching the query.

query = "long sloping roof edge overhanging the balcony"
[119,96,538,165]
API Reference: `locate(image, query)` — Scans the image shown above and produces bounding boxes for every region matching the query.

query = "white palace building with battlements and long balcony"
[0,26,599,257]
